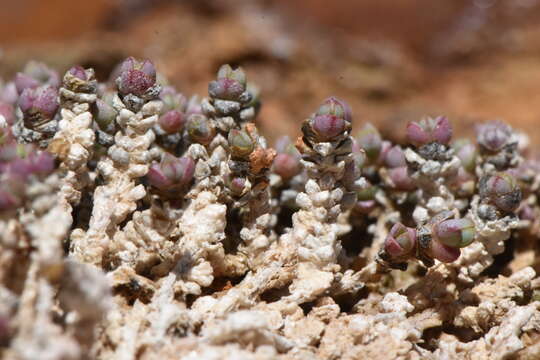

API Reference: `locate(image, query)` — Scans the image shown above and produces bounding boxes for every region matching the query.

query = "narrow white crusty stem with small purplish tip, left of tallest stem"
[48,67,97,207]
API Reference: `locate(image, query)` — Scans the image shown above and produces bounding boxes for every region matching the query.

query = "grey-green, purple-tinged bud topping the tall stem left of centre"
[208,65,246,100]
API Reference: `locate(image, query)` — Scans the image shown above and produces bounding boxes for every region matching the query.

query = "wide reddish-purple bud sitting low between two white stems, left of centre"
[146,153,195,191]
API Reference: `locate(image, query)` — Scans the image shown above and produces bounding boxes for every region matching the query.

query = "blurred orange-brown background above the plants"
[0,0,540,142]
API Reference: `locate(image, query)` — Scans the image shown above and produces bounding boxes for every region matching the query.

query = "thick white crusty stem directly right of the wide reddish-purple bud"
[174,125,233,294]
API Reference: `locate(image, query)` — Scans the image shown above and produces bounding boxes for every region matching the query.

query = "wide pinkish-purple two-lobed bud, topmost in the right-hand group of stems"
[407,116,452,147]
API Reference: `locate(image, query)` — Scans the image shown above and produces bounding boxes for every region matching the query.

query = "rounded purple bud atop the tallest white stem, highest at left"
[116,57,156,96]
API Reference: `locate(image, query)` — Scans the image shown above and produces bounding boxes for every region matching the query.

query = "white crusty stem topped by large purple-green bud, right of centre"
[281,98,358,301]
